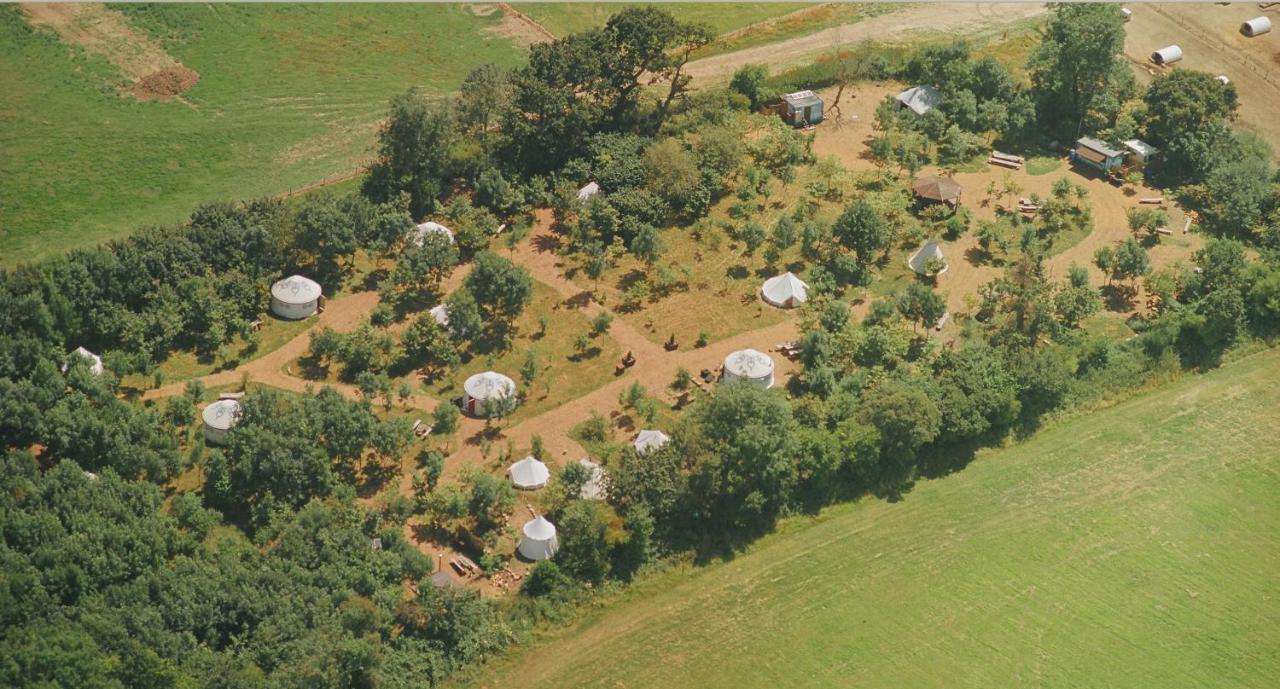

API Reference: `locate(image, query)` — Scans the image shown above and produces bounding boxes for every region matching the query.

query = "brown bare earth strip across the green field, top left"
[22,3,200,100]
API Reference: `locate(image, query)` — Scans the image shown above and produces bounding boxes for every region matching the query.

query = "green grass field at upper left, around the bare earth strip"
[0,4,522,265]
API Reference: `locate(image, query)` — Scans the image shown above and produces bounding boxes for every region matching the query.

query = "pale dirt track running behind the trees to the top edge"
[686,3,1048,79]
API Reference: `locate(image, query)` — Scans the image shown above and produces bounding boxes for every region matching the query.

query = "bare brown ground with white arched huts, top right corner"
[1125,3,1280,151]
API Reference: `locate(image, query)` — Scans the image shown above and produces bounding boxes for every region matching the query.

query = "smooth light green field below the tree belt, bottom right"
[460,351,1280,689]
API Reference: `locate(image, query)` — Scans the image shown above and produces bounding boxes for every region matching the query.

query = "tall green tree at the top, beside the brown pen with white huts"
[1028,3,1133,137]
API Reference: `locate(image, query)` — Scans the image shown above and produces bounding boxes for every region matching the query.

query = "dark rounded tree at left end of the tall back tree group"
[362,87,453,218]
